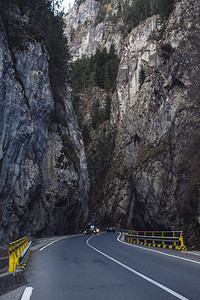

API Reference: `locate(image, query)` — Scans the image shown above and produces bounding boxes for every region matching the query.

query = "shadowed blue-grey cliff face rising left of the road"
[0,3,89,242]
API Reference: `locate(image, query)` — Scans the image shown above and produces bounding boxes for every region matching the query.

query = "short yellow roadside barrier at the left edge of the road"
[8,236,32,272]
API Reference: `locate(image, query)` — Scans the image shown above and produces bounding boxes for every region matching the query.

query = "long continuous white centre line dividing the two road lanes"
[86,236,189,300]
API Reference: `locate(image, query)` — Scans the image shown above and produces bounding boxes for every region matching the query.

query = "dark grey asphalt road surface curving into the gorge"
[22,232,200,300]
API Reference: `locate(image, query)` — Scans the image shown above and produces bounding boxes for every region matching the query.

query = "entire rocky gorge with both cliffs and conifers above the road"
[0,0,200,249]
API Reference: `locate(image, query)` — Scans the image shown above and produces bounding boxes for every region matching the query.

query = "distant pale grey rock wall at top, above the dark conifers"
[65,0,122,61]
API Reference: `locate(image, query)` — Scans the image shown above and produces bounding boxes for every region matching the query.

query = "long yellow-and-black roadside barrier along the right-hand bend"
[122,230,187,251]
